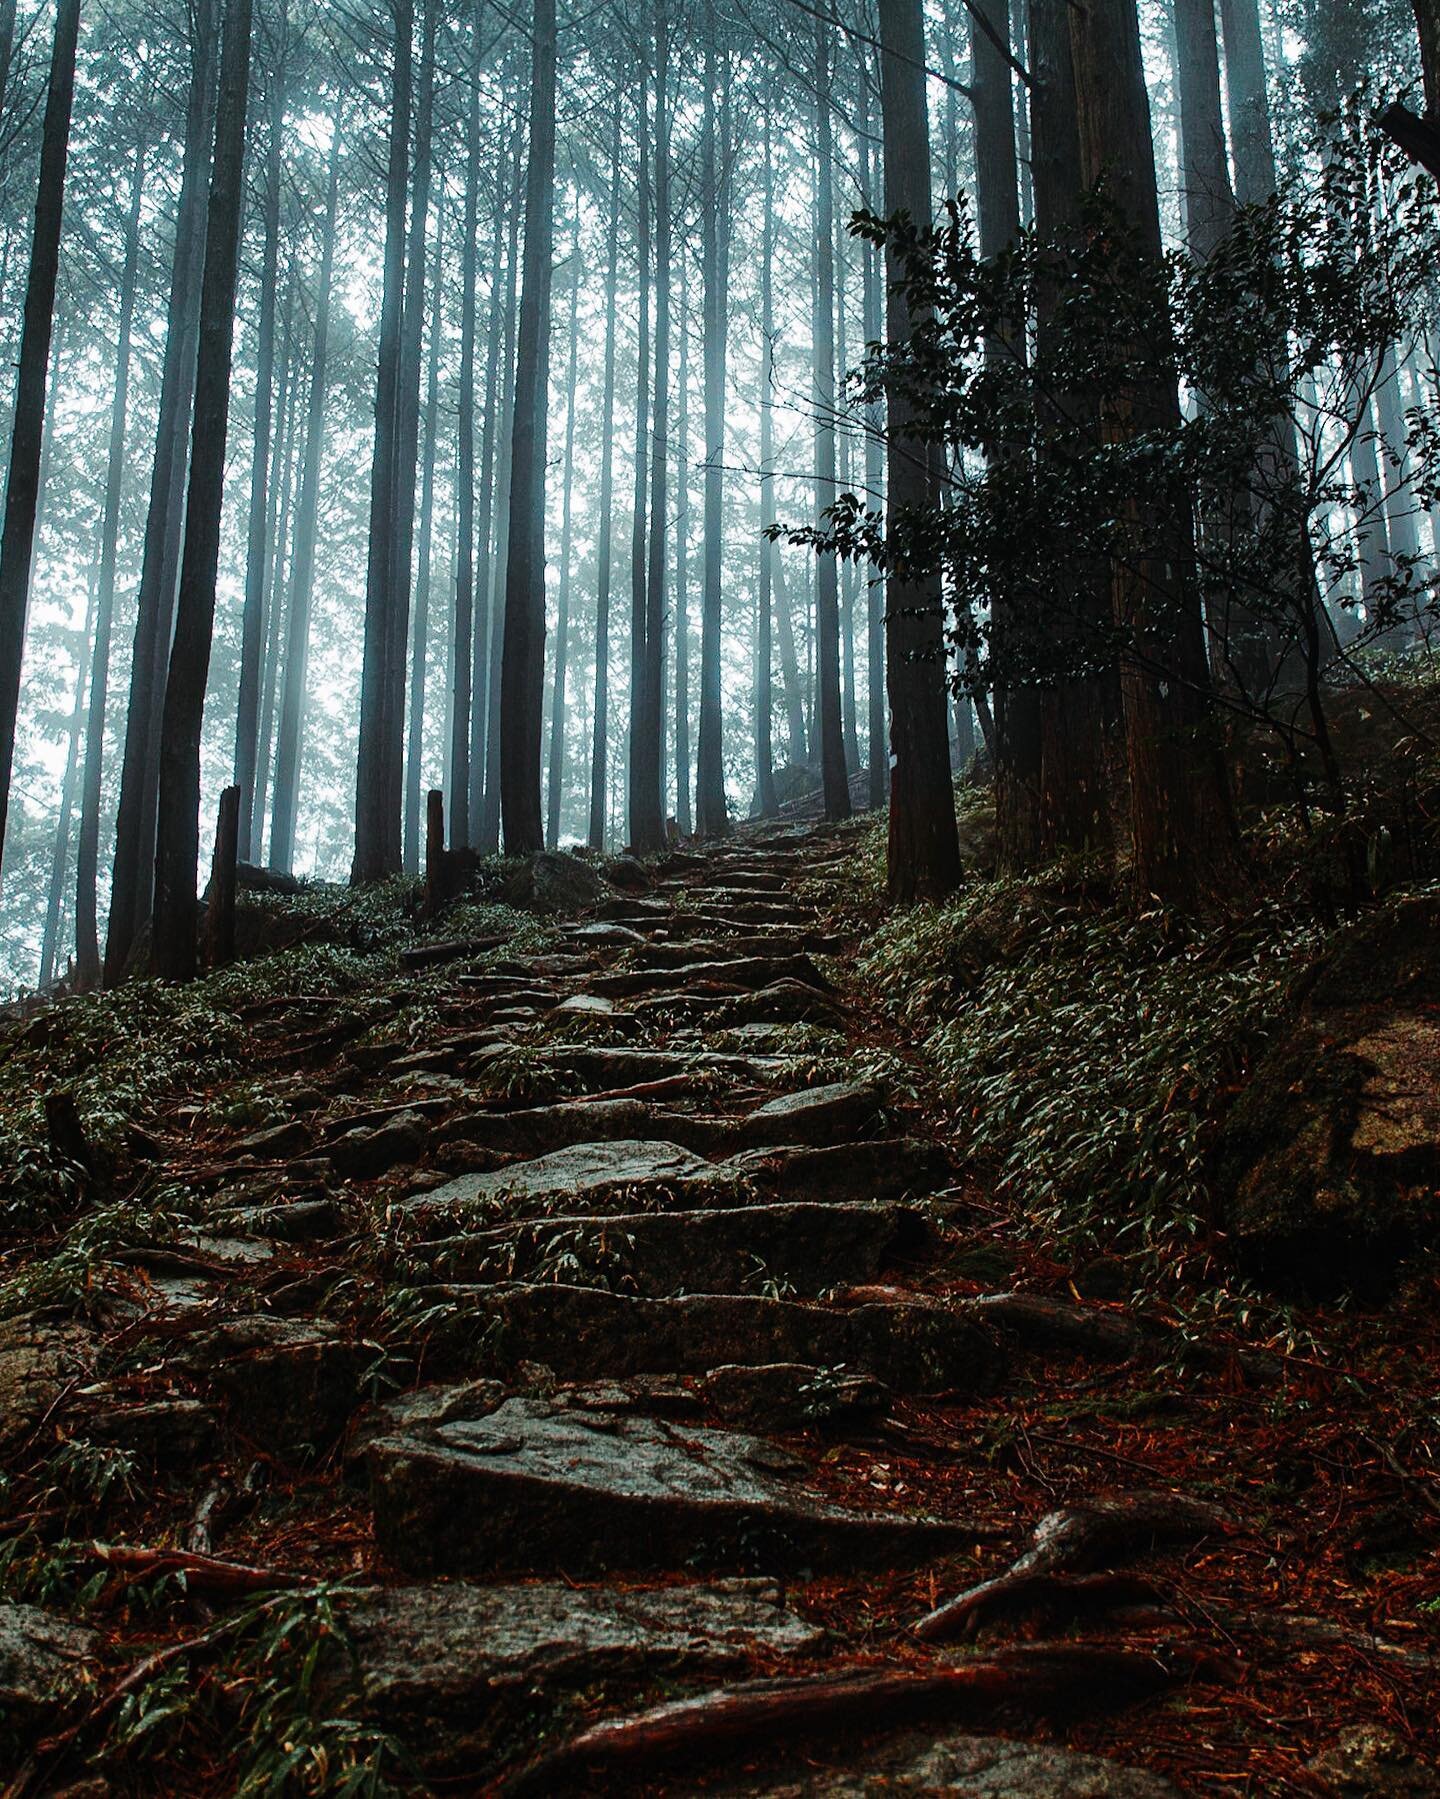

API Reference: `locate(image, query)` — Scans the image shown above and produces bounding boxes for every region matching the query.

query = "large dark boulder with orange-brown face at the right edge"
[1217,900,1440,1293]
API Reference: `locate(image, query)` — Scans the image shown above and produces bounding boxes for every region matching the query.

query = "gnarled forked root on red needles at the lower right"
[914,1493,1229,1642]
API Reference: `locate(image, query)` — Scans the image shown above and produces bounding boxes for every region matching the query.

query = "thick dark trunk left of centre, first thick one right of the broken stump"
[500,0,554,856]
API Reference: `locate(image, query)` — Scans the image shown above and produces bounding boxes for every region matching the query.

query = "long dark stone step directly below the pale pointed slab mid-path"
[423,1204,927,1299]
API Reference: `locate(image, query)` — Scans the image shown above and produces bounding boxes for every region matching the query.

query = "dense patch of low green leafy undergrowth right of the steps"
[860,871,1318,1256]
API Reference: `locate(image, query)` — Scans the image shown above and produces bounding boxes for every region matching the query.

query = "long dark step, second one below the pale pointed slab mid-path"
[450,1283,1003,1392]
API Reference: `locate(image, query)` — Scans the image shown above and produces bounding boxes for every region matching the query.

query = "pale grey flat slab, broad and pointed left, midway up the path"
[407,1137,742,1214]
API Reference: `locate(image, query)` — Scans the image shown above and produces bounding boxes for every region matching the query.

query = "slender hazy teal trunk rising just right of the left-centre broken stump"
[446,0,482,849]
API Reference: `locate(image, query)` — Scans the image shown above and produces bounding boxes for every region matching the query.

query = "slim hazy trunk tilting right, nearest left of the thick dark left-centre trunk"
[270,106,340,874]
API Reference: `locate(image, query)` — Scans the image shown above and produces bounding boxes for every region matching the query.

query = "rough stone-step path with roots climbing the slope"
[11,824,1425,1799]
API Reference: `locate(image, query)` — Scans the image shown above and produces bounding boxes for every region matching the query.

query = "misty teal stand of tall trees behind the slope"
[0,0,1436,989]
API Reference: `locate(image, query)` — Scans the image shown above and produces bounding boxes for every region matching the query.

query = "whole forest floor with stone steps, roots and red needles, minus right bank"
[0,822,1440,1799]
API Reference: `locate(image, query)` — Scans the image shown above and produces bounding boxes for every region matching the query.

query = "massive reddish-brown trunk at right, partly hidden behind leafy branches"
[1069,0,1233,903]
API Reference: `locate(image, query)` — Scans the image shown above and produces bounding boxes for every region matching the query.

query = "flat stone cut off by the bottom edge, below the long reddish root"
[707,1732,1181,1799]
